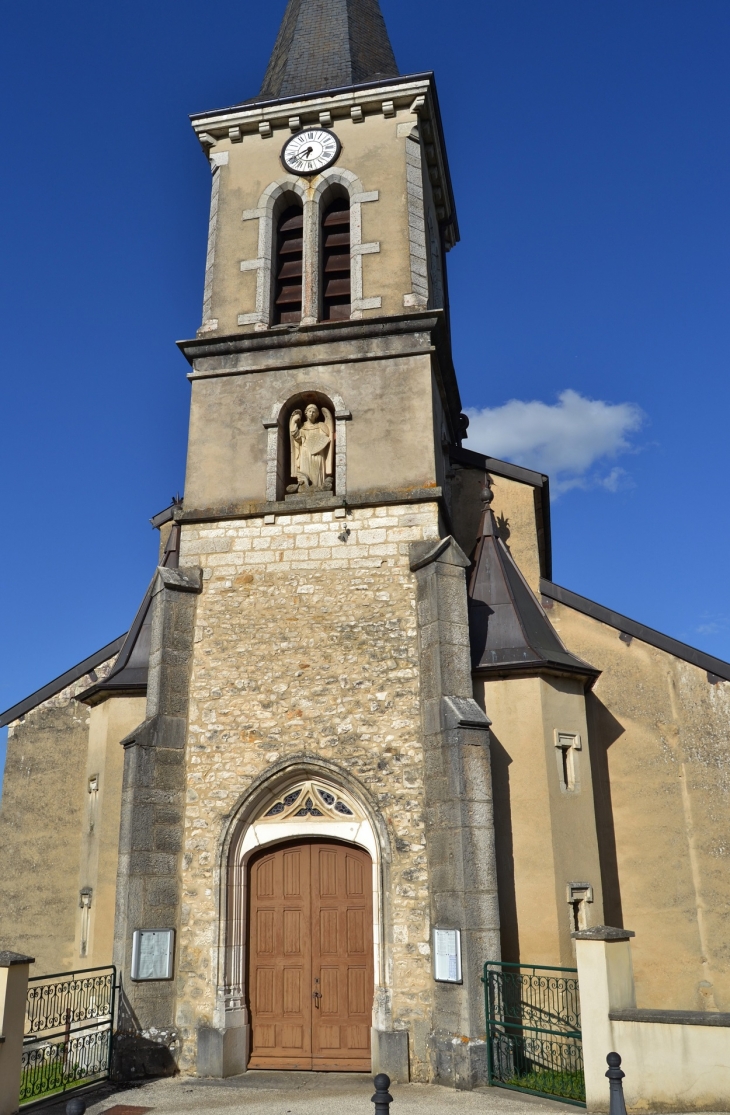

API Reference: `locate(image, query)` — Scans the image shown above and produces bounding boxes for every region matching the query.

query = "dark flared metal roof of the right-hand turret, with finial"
[468,487,601,680]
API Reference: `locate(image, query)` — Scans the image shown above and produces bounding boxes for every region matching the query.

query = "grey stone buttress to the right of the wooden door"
[411,537,499,1088]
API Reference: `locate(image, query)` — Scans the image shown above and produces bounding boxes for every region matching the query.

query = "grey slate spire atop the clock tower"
[259,0,398,99]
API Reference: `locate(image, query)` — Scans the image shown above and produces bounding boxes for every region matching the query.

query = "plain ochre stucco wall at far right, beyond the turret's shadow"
[547,601,730,1011]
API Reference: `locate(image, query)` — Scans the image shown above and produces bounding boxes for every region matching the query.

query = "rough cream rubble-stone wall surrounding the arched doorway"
[177,503,439,1079]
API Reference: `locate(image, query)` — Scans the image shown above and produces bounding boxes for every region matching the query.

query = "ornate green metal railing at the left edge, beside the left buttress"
[20,966,117,1104]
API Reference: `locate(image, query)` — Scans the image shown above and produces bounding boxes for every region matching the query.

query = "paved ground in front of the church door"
[37,1072,578,1115]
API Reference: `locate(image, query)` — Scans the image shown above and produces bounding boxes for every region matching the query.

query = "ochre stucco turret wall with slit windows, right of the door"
[475,677,603,967]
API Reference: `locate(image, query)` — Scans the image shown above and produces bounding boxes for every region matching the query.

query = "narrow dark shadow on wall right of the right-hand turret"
[585,692,624,929]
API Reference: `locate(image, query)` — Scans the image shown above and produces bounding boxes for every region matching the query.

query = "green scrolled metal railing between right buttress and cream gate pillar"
[483,960,585,1107]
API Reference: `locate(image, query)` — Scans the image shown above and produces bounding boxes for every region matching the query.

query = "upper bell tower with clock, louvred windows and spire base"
[181,0,460,518]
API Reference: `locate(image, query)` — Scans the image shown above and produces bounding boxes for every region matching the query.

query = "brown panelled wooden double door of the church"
[249,838,373,1072]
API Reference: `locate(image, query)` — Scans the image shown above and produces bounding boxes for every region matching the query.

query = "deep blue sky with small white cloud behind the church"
[0,0,730,776]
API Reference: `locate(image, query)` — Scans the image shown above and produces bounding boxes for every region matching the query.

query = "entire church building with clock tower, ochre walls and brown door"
[0,0,730,1088]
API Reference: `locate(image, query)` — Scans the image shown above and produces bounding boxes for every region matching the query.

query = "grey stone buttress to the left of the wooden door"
[114,566,202,1078]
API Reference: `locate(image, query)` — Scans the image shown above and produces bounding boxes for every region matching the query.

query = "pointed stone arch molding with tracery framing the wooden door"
[213,756,391,1052]
